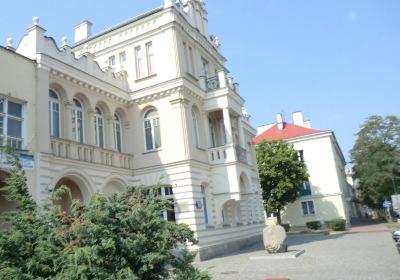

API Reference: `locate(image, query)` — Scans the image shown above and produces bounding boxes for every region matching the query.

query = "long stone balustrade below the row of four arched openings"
[51,138,133,169]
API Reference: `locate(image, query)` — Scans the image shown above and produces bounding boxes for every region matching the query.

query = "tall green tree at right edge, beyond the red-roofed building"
[350,116,400,208]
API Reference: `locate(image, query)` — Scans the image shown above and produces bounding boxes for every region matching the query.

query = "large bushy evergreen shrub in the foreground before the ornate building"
[0,148,210,280]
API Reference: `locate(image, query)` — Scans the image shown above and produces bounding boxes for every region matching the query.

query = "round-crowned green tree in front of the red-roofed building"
[256,141,308,224]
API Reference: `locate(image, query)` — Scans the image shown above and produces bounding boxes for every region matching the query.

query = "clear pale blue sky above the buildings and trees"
[0,0,400,161]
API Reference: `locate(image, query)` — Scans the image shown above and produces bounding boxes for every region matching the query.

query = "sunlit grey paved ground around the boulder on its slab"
[197,228,400,280]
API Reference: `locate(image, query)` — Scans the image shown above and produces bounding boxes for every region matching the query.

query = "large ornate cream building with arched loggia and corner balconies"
[0,0,264,259]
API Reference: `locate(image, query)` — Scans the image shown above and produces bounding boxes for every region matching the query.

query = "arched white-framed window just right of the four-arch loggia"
[144,109,161,151]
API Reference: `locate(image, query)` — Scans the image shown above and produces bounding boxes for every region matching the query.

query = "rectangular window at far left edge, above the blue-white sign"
[0,99,23,149]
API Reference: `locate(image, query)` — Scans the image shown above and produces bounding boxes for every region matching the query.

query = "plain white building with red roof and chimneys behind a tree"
[255,112,357,227]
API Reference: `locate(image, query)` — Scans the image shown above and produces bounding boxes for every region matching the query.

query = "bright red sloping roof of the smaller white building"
[254,123,325,144]
